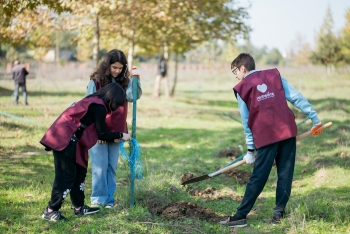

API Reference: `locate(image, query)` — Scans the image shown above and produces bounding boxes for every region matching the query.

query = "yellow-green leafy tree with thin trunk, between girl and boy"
[145,0,250,95]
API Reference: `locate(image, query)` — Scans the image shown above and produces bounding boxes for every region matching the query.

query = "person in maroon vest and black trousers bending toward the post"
[40,83,130,221]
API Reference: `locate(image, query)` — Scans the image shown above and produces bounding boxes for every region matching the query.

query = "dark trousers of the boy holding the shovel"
[237,137,296,216]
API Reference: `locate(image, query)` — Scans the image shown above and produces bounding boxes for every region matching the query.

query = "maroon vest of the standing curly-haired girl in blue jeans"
[93,79,128,133]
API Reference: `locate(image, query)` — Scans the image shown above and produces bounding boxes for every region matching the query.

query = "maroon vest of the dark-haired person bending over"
[40,97,107,168]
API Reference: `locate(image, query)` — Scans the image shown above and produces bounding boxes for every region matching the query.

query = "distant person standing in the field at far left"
[12,59,29,105]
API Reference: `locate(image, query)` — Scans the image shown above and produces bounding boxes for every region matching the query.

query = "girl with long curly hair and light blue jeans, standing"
[86,49,142,208]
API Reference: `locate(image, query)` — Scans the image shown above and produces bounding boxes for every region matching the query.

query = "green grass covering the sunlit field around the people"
[0,68,350,233]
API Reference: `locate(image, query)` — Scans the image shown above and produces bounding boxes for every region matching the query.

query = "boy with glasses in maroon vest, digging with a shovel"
[220,53,322,227]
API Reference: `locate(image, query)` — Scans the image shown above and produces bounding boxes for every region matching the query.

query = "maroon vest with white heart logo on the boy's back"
[233,69,297,149]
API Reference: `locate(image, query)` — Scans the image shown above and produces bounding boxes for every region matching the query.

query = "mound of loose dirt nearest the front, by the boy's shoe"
[153,201,224,222]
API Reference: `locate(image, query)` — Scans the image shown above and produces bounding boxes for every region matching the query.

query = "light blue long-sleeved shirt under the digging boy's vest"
[237,70,320,149]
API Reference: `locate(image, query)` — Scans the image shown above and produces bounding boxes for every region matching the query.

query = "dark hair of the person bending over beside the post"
[87,83,126,111]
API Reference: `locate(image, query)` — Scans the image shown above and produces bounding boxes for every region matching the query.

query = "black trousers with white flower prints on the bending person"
[48,148,87,211]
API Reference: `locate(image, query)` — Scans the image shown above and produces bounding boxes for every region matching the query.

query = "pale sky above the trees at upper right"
[241,0,350,55]
